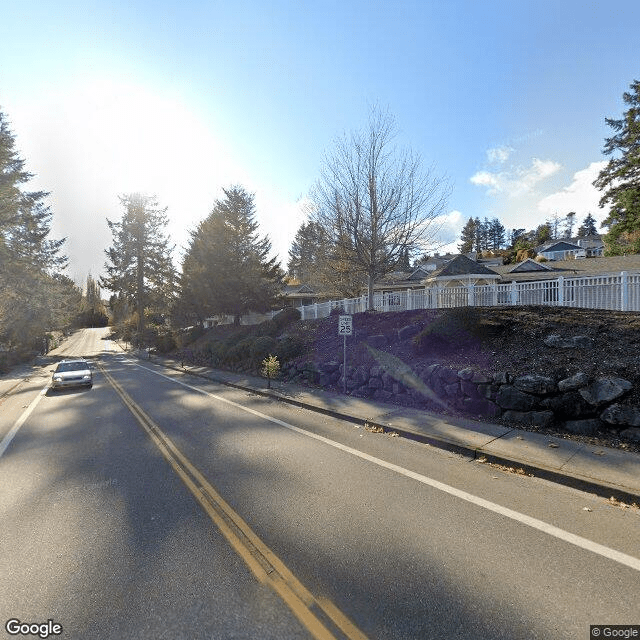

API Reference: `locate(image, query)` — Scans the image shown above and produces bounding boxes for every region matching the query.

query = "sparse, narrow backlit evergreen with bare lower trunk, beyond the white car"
[100,193,177,334]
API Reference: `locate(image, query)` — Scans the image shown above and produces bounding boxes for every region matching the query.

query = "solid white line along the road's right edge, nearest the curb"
[133,363,640,571]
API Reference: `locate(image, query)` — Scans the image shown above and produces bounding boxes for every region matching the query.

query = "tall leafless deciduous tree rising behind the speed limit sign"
[310,108,450,309]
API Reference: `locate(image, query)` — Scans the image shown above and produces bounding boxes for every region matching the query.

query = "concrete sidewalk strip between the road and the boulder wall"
[134,354,640,504]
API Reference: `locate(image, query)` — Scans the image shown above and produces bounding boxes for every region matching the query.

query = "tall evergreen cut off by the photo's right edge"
[593,80,640,255]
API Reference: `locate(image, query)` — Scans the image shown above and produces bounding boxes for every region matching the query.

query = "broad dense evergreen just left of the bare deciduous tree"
[179,186,284,324]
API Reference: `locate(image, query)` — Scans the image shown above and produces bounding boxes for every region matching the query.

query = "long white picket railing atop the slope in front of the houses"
[288,271,640,320]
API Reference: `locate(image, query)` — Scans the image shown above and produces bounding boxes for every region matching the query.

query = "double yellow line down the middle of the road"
[98,363,367,640]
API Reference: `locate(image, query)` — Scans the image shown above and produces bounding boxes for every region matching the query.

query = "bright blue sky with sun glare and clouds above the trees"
[0,0,640,280]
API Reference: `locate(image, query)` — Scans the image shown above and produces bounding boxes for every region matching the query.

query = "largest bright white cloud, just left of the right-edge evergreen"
[538,161,608,228]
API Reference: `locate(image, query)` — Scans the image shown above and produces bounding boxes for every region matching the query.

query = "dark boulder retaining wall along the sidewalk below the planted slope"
[282,362,640,442]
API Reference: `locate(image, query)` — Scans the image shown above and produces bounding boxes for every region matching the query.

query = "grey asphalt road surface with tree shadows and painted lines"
[0,329,640,640]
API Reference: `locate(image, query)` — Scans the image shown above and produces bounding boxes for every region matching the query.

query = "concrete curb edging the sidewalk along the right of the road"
[126,354,640,504]
